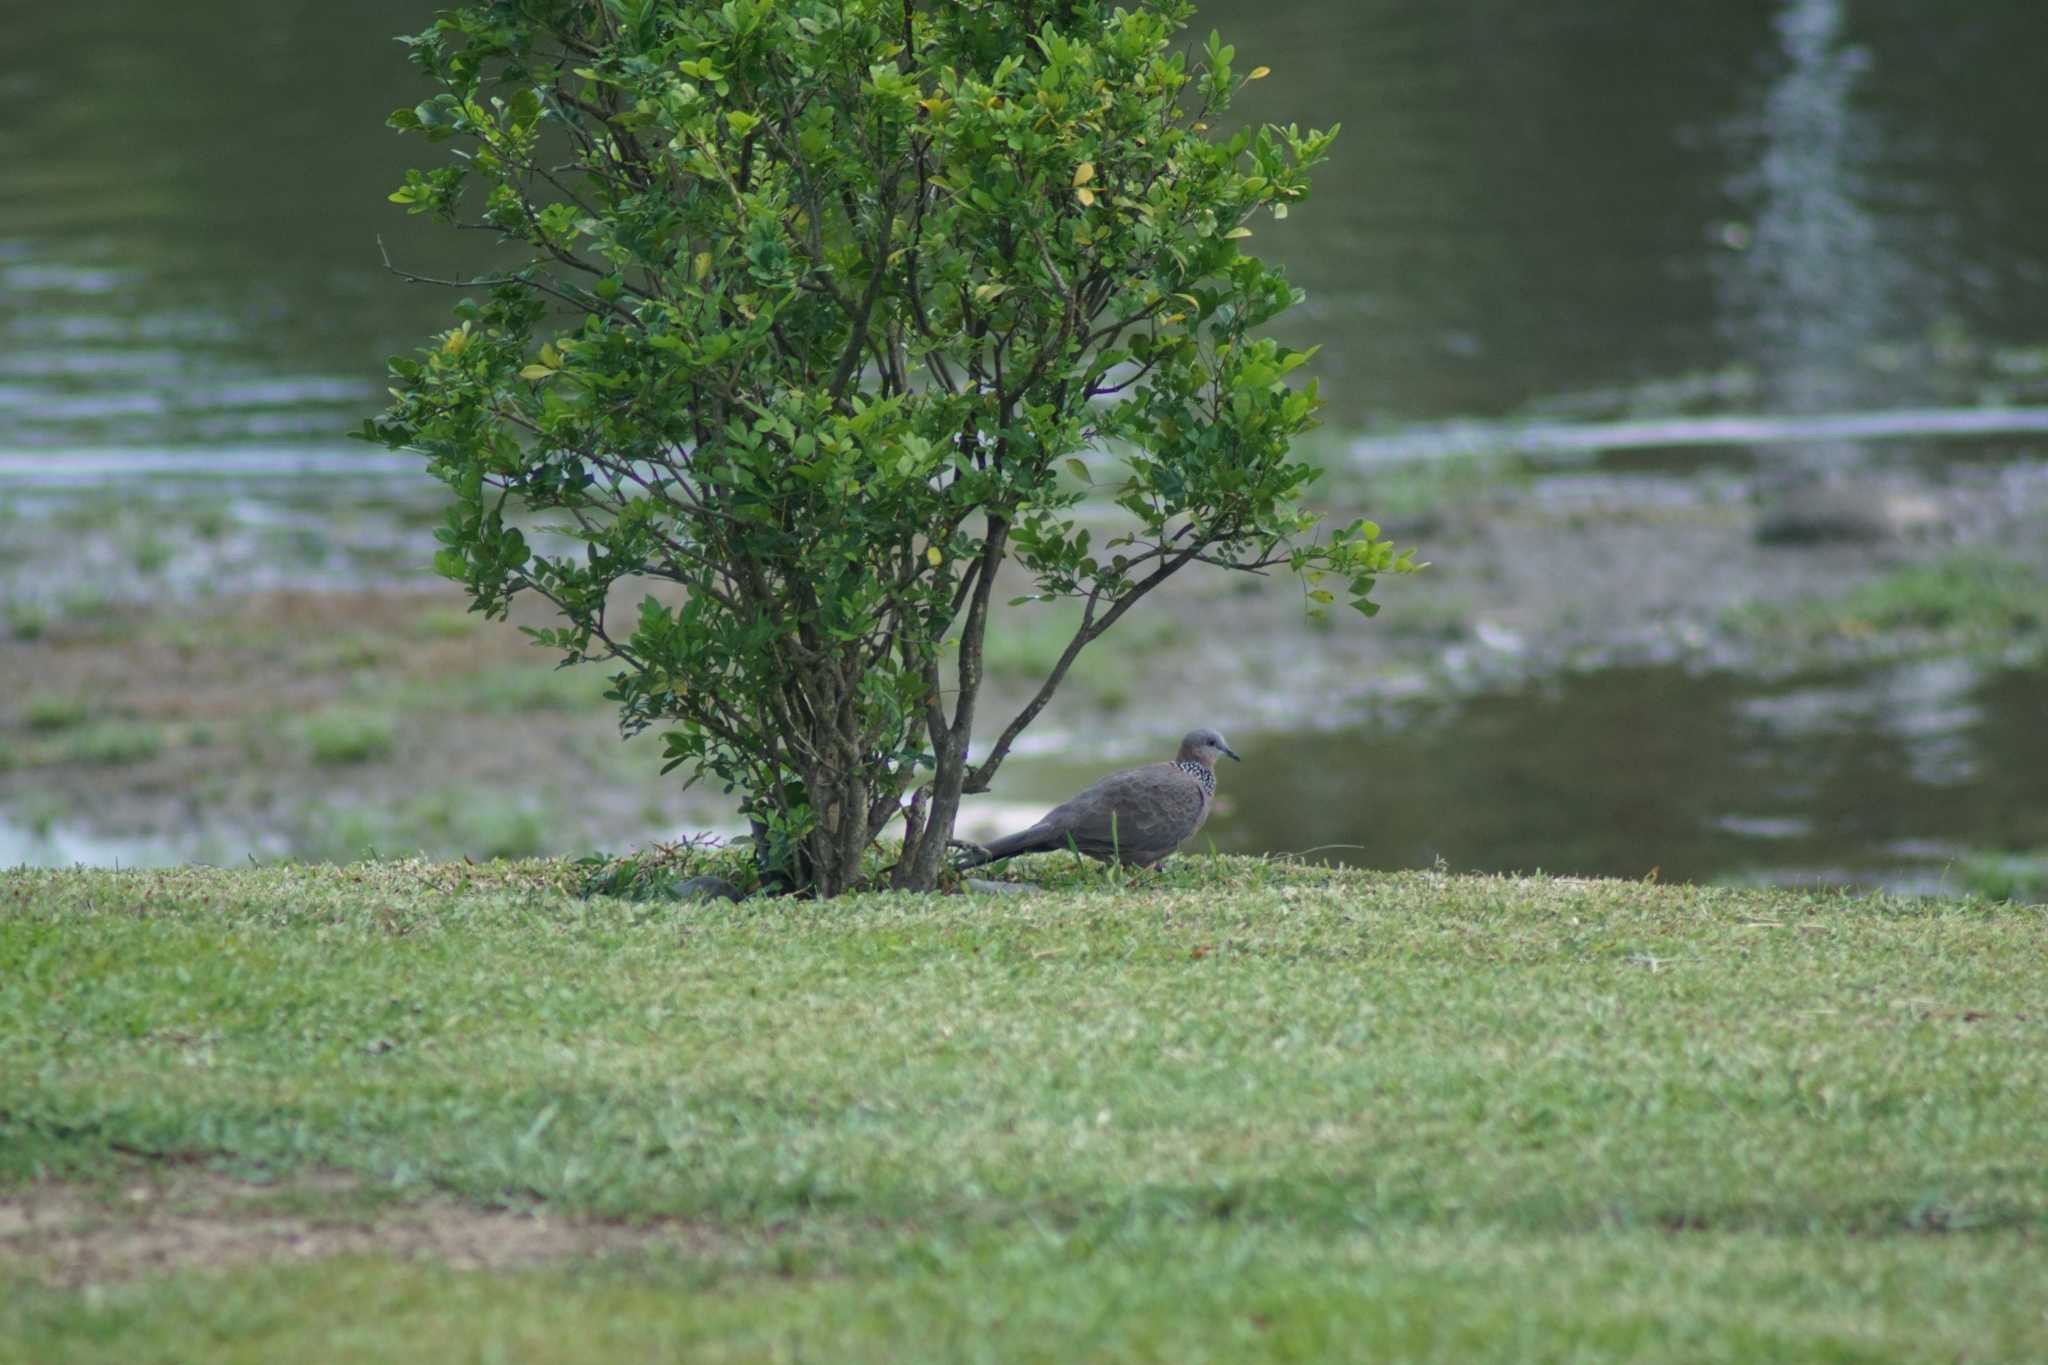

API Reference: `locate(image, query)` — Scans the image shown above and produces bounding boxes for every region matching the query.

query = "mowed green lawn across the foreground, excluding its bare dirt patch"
[0,857,2048,1361]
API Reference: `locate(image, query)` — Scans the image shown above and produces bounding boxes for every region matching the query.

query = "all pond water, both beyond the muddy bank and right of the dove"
[0,0,2048,878]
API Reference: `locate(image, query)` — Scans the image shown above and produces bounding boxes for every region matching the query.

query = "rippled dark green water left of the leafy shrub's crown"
[0,0,451,456]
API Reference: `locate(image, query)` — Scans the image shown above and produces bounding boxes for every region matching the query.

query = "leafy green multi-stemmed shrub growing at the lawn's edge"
[372,0,1415,896]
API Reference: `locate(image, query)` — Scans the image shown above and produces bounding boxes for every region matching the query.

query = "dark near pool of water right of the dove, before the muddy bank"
[1030,659,2048,892]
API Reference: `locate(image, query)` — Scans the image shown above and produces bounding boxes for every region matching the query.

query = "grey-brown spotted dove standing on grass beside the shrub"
[961,731,1241,868]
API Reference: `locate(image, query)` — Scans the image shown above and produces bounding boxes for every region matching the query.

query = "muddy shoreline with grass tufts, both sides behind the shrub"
[0,452,2048,875]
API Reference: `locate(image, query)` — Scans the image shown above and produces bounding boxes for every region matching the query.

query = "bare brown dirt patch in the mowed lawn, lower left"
[0,1171,729,1289]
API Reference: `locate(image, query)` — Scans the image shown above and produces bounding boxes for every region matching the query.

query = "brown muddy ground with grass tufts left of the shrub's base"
[0,589,719,862]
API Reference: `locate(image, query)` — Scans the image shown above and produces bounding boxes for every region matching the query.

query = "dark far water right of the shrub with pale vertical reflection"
[1202,0,2048,420]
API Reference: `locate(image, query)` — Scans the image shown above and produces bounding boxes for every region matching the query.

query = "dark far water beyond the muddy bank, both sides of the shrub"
[0,0,2048,439]
